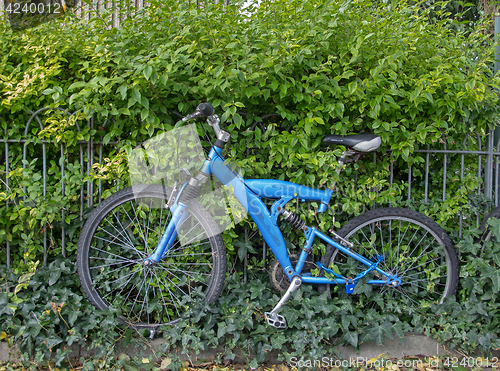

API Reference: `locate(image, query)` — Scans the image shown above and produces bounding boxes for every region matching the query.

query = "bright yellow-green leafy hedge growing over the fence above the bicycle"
[0,0,498,269]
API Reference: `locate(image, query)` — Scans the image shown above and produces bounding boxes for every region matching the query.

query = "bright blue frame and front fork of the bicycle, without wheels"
[144,142,401,286]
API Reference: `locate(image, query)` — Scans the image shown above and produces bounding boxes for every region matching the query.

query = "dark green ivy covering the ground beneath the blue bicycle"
[0,224,500,369]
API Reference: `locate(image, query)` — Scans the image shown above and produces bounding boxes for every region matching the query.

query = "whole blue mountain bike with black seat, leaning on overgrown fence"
[78,103,458,333]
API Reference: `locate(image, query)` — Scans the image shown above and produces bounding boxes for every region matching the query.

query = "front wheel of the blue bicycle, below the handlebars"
[77,185,226,329]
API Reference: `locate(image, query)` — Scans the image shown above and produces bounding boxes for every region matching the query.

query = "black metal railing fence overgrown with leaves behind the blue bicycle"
[0,108,500,267]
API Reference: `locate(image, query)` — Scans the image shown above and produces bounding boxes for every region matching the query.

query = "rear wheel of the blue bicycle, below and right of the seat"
[321,208,458,307]
